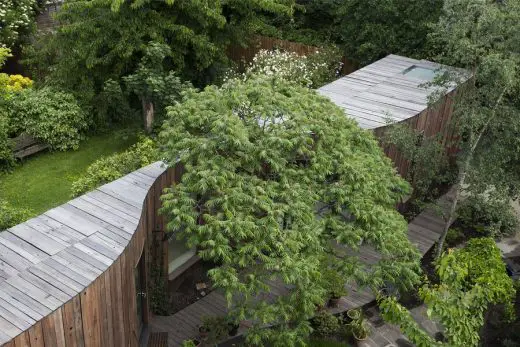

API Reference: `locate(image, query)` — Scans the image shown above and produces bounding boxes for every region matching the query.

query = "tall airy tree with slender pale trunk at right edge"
[431,0,520,259]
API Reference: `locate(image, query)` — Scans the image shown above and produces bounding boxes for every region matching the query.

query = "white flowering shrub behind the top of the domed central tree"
[225,50,342,88]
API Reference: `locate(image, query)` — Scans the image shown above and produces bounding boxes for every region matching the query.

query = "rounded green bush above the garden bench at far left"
[10,88,88,151]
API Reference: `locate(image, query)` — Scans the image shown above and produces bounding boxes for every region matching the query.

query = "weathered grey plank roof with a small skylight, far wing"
[318,54,453,129]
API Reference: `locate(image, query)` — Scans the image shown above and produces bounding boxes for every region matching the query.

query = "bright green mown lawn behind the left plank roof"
[0,132,136,215]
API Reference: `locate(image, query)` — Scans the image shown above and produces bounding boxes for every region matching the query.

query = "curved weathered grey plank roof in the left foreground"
[0,162,166,345]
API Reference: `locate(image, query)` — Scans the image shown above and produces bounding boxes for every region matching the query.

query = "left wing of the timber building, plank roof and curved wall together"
[0,163,174,347]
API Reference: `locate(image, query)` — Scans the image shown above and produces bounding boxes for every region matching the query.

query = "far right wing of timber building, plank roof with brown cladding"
[318,55,463,176]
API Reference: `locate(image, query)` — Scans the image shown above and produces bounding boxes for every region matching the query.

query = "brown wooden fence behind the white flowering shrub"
[227,36,359,75]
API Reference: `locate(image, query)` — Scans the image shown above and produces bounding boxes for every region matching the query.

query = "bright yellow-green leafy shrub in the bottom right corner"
[379,238,515,347]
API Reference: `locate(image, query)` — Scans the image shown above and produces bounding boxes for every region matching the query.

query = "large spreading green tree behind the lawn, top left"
[27,0,293,127]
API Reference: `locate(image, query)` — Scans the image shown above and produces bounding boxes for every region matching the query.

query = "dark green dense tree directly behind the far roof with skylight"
[259,0,443,65]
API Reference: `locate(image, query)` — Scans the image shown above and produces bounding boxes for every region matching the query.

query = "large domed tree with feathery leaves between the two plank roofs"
[161,77,418,346]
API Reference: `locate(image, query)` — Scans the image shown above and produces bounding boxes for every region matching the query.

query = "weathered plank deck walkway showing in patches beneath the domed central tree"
[150,192,452,347]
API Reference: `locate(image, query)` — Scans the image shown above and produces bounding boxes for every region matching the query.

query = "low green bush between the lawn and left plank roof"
[72,138,159,197]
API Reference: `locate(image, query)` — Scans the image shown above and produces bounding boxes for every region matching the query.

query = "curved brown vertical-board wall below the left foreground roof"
[3,169,175,347]
